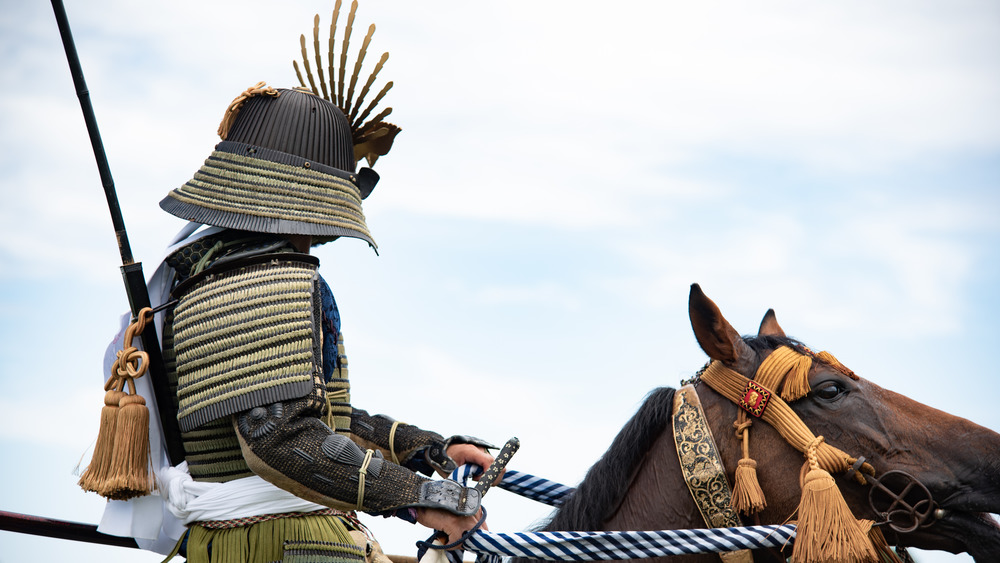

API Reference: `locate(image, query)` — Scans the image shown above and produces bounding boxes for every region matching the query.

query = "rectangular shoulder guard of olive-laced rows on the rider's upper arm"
[174,253,322,432]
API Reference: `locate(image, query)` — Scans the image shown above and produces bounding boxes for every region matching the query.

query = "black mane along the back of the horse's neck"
[544,387,674,531]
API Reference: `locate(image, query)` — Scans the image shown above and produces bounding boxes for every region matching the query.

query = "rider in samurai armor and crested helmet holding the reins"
[93,1,493,563]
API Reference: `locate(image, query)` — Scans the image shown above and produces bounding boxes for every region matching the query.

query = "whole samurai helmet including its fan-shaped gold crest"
[160,0,400,247]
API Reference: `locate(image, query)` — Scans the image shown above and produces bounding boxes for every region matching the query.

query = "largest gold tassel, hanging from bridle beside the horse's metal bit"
[792,436,878,563]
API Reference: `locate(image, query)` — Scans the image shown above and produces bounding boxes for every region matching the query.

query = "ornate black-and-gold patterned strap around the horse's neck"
[672,385,753,563]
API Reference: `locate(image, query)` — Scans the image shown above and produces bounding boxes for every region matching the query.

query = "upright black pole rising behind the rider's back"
[52,0,184,465]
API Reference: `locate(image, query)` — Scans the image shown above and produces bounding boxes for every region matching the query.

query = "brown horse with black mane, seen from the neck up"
[522,284,1000,563]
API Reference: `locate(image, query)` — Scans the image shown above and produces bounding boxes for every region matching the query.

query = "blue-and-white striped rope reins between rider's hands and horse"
[424,465,795,563]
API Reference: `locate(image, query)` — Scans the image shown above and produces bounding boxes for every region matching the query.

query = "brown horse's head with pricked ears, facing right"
[689,284,1000,562]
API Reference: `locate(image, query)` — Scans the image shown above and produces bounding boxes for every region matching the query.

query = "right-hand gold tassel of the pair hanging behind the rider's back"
[105,395,153,500]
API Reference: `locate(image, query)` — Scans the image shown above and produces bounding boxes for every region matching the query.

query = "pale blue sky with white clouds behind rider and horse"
[0,0,1000,563]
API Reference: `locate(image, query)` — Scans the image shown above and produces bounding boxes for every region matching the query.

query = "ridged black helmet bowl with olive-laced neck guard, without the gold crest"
[160,83,378,247]
